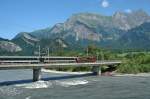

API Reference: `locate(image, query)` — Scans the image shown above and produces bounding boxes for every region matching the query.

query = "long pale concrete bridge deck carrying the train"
[0,61,122,70]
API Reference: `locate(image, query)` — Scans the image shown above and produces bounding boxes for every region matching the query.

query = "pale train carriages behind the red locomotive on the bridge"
[0,56,77,64]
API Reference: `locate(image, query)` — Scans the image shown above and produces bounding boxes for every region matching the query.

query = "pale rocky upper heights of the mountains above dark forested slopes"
[31,10,150,41]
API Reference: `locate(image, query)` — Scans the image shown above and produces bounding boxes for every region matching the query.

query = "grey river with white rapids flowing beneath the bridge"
[0,70,150,99]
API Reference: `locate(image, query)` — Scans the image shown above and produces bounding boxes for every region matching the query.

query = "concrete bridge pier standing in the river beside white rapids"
[33,68,41,82]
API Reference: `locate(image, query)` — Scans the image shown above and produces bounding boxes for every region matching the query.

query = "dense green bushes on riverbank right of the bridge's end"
[117,52,150,74]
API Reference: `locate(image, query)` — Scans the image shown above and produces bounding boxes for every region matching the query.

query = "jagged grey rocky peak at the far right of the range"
[112,10,150,30]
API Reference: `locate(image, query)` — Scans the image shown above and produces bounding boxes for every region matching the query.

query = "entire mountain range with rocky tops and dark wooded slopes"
[0,10,150,54]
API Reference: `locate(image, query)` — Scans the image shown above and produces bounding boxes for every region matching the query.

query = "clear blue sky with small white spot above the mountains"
[0,0,150,39]
